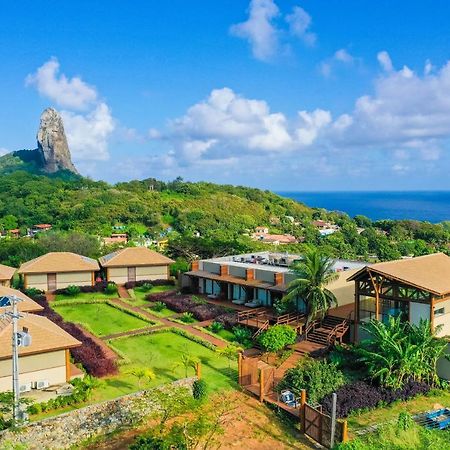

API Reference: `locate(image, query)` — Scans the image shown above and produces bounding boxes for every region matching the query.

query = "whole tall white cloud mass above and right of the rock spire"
[25,58,116,162]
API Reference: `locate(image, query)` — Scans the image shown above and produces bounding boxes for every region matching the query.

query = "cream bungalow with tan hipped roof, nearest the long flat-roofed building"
[99,247,174,284]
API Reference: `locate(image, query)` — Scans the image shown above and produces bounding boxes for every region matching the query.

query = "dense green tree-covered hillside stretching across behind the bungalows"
[0,171,450,265]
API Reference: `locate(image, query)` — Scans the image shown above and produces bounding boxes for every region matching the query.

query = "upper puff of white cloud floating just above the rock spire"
[25,58,97,110]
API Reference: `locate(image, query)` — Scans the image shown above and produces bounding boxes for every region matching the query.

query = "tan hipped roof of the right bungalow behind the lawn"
[99,247,175,267]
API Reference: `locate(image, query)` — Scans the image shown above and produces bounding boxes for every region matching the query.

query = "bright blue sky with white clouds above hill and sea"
[0,0,450,191]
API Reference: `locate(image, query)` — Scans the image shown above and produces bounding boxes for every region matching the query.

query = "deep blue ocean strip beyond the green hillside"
[277,191,450,223]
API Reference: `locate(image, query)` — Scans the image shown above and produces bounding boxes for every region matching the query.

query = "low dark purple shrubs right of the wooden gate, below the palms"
[322,380,430,417]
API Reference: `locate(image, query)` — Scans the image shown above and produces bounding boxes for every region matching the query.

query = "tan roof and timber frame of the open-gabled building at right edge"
[348,253,450,342]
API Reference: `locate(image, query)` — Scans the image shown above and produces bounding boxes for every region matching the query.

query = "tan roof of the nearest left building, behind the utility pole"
[0,314,81,359]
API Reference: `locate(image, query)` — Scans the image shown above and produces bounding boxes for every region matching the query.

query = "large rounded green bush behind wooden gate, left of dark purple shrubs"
[277,358,345,404]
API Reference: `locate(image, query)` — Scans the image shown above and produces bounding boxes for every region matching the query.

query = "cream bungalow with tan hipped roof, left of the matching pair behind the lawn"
[18,252,100,292]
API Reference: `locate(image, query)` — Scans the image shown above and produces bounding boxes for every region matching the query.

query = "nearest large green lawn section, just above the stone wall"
[93,332,237,401]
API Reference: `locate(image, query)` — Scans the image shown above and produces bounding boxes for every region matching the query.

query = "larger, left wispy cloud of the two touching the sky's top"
[230,0,279,61]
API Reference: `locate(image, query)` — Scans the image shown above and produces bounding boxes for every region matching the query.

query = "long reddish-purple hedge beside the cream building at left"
[34,296,117,377]
